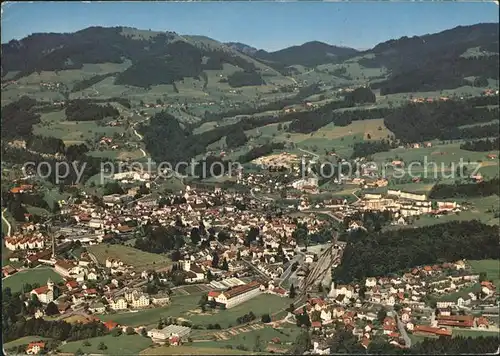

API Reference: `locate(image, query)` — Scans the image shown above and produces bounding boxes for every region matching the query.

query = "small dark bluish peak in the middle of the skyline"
[253,41,358,67]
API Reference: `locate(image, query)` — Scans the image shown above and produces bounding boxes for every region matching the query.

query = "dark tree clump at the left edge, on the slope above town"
[1,96,40,140]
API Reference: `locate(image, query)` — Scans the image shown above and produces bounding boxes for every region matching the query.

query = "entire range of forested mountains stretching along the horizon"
[1,23,499,94]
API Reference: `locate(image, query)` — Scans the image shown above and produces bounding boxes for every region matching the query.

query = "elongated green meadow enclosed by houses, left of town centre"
[87,244,172,271]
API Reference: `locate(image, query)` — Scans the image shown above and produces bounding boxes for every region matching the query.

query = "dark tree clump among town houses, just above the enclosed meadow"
[134,224,185,253]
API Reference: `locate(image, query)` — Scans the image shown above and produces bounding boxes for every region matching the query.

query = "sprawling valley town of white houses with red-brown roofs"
[2,163,498,354]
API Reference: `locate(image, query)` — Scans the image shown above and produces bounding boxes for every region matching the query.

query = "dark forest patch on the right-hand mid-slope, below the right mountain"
[384,100,498,142]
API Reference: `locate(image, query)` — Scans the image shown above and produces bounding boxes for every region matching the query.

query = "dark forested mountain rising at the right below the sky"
[359,23,500,94]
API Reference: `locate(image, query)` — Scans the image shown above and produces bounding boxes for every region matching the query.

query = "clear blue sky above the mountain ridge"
[1,0,499,51]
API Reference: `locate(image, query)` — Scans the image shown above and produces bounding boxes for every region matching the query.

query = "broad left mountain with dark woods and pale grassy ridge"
[1,27,279,88]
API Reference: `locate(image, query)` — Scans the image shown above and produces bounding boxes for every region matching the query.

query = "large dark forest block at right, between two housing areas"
[334,220,498,284]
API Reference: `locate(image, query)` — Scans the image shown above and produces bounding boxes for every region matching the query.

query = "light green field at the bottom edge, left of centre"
[60,334,153,355]
